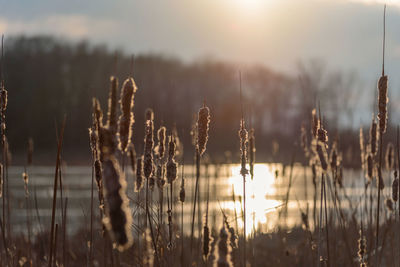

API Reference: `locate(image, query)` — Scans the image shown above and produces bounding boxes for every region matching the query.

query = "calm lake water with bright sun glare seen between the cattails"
[0,164,390,238]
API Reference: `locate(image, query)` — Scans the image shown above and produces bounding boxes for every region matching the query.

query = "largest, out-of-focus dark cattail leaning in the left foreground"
[103,155,132,251]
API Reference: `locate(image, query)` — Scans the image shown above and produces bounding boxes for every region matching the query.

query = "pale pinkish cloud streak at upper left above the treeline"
[0,14,115,39]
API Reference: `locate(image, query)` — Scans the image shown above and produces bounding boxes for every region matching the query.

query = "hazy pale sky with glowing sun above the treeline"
[0,0,400,113]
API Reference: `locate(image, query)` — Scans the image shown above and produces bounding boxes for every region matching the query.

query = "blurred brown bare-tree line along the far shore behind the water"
[3,36,384,164]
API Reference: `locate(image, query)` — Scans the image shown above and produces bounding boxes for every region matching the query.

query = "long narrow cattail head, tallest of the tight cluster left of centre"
[143,109,154,179]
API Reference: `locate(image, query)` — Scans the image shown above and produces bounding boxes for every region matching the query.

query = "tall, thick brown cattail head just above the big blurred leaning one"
[119,78,137,152]
